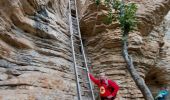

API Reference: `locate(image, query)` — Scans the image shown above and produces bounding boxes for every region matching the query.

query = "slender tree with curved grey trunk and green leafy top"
[96,0,154,100]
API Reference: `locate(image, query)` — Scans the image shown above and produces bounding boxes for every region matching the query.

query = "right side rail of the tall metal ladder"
[74,0,95,100]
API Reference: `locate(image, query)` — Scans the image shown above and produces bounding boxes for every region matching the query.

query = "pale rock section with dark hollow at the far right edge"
[146,13,170,99]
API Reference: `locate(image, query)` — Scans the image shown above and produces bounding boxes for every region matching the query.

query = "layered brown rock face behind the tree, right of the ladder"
[81,0,170,100]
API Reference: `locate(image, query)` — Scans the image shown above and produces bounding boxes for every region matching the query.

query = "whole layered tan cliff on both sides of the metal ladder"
[0,0,170,100]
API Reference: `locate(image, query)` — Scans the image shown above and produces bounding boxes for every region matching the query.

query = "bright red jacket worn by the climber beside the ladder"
[89,74,119,97]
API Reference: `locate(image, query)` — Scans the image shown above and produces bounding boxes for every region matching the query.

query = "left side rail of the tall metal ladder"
[69,0,82,100]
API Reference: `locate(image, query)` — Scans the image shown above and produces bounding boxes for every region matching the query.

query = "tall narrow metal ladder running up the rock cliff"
[69,0,95,100]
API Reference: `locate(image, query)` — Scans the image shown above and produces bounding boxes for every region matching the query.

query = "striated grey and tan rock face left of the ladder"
[0,0,76,100]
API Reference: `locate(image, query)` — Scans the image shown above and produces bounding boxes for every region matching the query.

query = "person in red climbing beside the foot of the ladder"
[89,73,119,100]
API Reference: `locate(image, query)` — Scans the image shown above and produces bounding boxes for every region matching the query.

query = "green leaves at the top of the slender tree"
[96,0,137,34]
